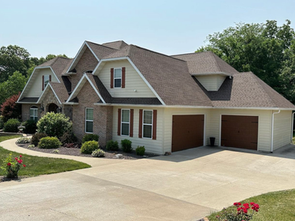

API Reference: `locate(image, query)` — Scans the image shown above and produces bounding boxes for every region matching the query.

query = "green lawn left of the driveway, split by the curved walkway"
[0,136,90,177]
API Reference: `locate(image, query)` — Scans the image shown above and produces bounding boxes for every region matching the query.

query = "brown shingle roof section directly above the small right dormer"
[172,51,239,75]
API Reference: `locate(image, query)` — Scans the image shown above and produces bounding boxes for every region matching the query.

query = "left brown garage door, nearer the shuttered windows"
[172,115,204,152]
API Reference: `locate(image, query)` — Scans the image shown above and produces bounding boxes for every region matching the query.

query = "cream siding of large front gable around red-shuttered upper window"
[98,60,156,97]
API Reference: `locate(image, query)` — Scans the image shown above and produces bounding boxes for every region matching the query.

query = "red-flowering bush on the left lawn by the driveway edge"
[1,153,26,178]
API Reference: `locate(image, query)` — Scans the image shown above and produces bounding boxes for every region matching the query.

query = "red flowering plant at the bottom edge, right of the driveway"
[216,202,259,221]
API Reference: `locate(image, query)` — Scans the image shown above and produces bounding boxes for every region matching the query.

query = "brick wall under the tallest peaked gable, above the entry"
[70,48,98,90]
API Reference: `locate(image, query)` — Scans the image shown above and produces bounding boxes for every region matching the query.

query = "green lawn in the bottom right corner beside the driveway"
[208,189,295,221]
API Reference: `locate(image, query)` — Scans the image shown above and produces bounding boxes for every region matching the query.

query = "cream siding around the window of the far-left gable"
[25,68,58,97]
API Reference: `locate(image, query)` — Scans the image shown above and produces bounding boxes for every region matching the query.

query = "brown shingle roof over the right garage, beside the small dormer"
[196,72,295,108]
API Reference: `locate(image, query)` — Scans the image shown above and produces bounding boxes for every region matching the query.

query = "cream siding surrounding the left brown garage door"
[163,108,210,153]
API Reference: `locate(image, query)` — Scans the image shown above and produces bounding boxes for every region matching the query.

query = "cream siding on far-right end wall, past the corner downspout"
[274,111,293,150]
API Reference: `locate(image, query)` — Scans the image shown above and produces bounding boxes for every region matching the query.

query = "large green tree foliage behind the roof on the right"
[196,20,295,103]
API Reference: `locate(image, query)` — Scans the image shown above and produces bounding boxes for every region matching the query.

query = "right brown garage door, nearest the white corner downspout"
[221,115,258,150]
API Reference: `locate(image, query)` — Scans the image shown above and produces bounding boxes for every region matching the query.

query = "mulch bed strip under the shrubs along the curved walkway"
[17,144,157,160]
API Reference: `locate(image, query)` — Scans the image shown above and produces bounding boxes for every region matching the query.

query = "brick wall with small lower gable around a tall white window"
[73,81,113,146]
